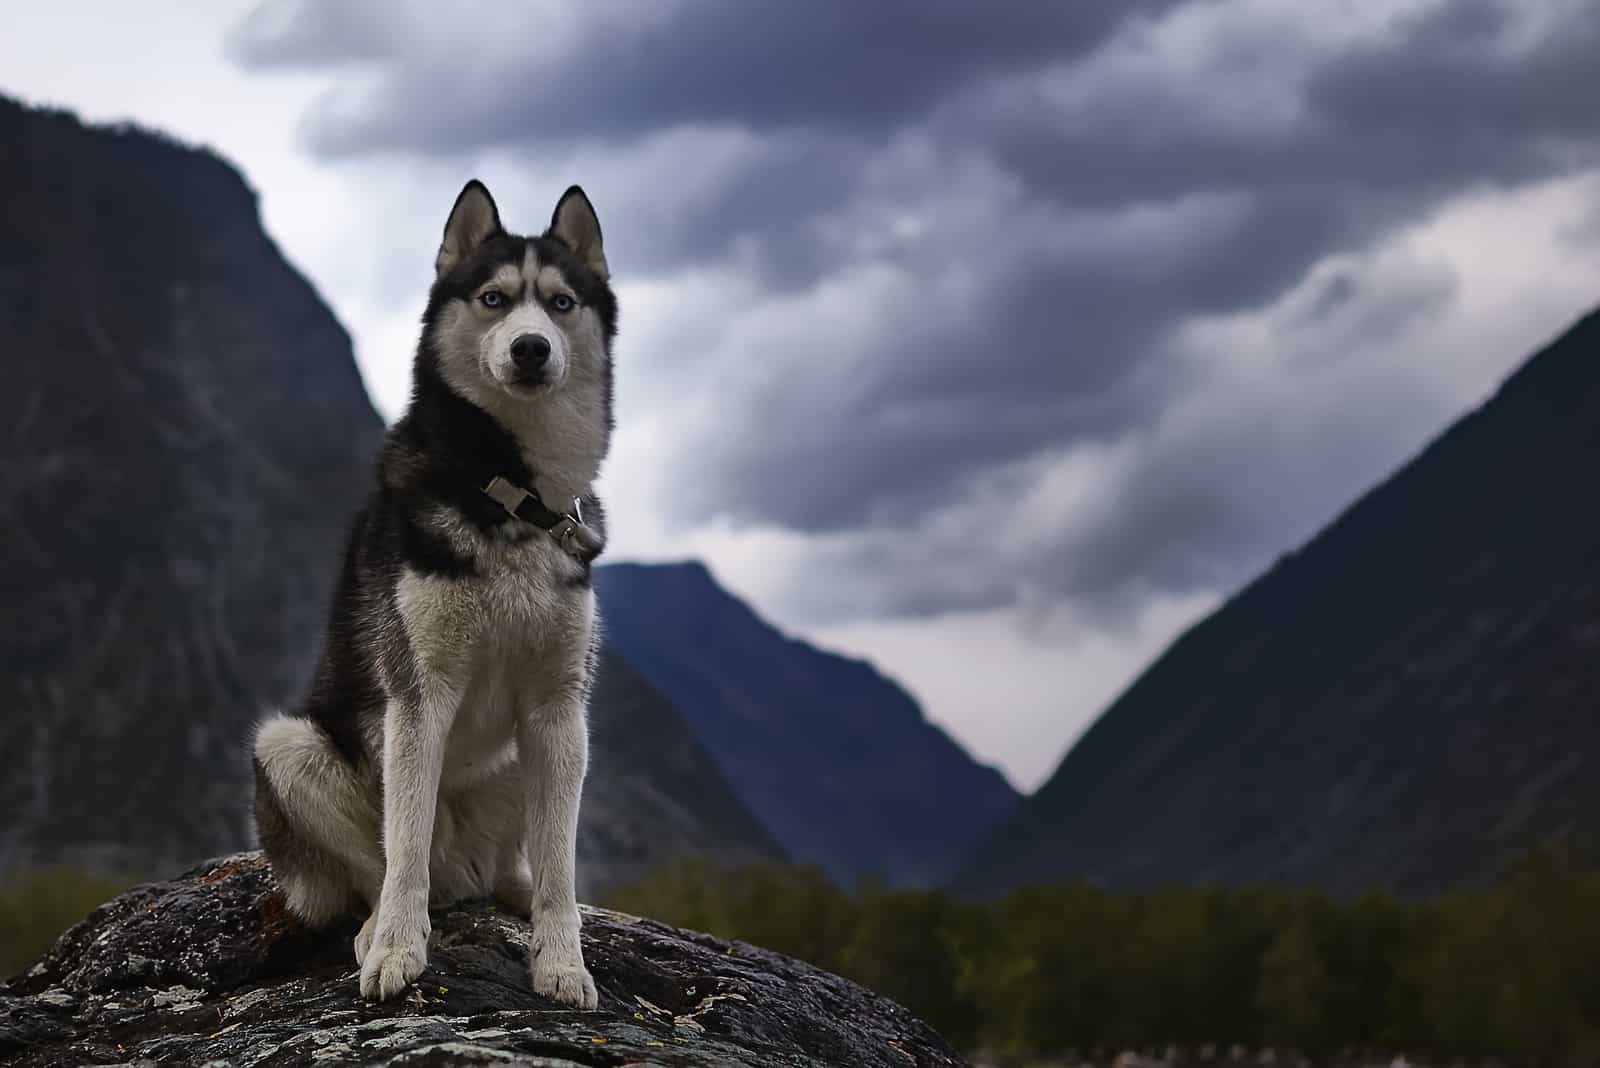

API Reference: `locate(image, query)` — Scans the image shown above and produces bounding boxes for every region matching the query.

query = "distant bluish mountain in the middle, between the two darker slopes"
[595,563,1016,884]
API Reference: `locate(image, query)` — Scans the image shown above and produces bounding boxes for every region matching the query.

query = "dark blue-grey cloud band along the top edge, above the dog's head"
[232,0,1166,155]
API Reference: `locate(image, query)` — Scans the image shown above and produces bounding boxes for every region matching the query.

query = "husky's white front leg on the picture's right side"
[517,692,598,1009]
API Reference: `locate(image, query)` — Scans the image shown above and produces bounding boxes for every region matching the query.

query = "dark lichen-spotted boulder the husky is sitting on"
[0,852,965,1068]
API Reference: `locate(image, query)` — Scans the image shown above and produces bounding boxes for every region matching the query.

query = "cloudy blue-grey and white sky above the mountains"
[0,0,1600,788]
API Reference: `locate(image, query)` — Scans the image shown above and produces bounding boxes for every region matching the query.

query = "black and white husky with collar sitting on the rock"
[254,181,616,1009]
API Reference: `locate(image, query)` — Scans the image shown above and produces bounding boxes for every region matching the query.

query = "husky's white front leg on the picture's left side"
[362,678,458,1001]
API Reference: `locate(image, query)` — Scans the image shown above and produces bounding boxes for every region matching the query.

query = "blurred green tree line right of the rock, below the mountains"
[606,852,1600,1065]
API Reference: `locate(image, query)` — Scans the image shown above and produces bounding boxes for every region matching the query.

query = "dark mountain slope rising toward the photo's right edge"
[957,312,1600,894]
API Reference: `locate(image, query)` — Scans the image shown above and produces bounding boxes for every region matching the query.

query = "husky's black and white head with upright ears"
[422,181,616,411]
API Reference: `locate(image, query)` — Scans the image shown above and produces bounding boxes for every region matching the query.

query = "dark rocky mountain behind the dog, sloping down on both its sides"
[0,98,782,892]
